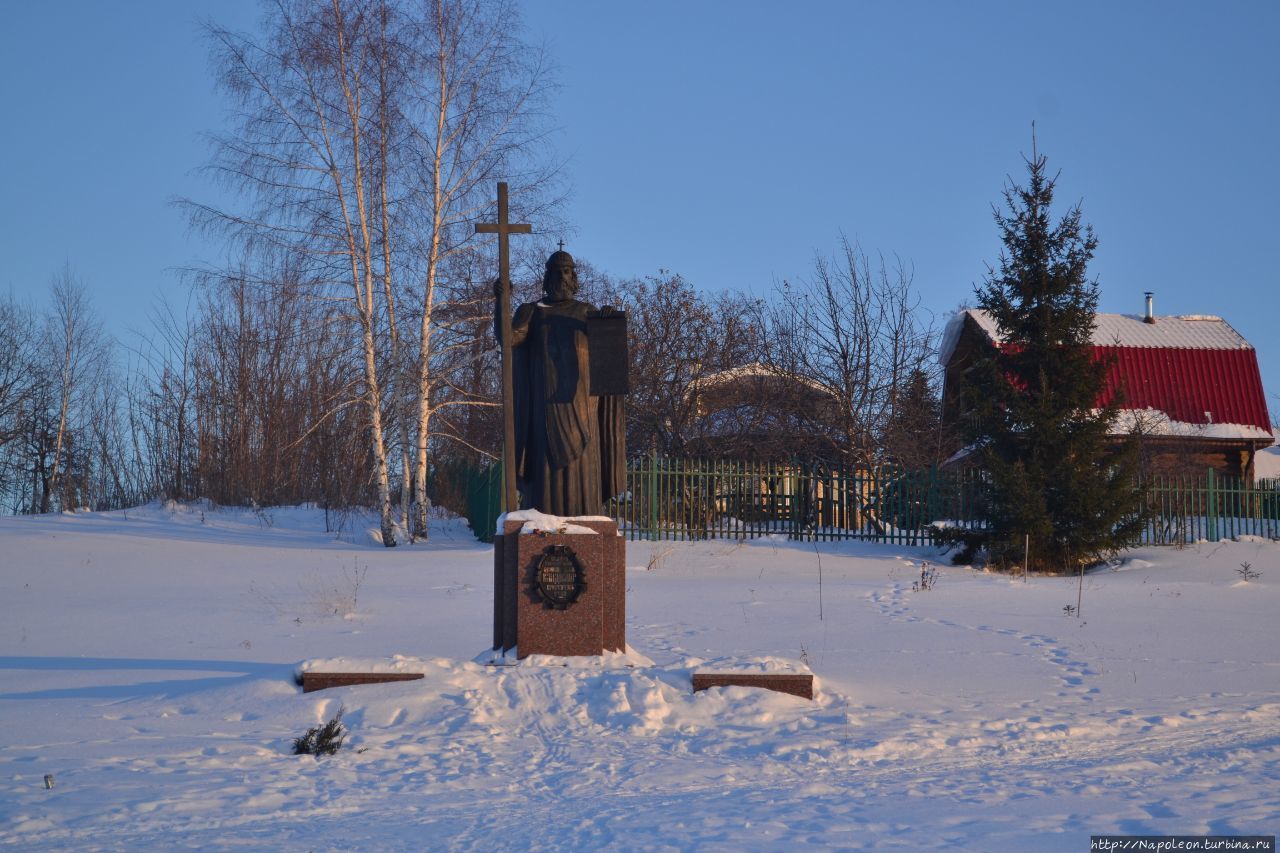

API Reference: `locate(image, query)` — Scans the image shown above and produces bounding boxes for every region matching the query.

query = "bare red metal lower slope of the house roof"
[1094,347,1271,429]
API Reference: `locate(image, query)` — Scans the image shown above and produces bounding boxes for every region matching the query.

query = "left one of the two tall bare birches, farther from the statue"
[189,0,397,547]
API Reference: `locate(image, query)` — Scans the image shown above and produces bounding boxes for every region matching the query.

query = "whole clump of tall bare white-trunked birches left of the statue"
[189,0,553,546]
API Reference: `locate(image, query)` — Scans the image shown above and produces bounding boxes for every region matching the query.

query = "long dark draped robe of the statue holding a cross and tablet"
[512,300,626,516]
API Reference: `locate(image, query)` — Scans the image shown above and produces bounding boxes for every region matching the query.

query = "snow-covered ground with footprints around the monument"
[0,506,1280,850]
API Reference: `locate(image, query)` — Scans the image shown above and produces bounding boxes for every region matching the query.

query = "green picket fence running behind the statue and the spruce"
[453,456,1280,544]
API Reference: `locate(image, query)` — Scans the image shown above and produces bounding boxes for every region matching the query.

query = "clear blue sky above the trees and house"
[0,0,1280,418]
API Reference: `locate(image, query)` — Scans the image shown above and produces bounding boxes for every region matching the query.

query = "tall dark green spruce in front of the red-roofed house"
[965,146,1142,571]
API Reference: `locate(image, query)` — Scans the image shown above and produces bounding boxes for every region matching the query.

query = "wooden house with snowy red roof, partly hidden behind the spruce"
[938,295,1275,482]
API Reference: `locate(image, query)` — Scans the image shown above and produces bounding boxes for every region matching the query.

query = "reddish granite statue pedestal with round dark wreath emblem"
[493,510,626,658]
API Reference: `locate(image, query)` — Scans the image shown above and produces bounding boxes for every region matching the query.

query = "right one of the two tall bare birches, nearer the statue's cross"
[394,0,557,535]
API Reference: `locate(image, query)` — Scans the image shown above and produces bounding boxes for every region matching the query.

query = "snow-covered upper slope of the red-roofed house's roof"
[938,309,1253,365]
